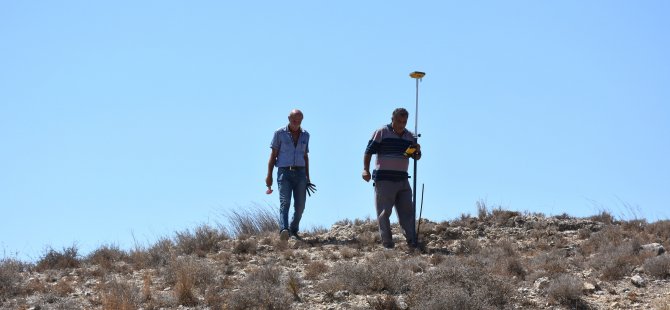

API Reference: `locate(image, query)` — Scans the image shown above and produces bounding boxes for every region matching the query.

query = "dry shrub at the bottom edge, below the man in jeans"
[227,266,293,310]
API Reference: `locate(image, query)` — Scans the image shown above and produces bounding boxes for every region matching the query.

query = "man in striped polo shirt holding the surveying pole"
[363,108,421,248]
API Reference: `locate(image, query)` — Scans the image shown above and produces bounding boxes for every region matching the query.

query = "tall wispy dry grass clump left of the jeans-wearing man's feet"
[224,205,279,237]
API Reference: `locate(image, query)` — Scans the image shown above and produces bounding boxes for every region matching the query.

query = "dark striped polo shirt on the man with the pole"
[365,124,416,181]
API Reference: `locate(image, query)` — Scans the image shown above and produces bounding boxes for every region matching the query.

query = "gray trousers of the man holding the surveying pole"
[375,180,416,247]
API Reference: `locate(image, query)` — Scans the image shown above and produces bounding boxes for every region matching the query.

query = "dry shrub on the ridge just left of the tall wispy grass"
[175,225,228,257]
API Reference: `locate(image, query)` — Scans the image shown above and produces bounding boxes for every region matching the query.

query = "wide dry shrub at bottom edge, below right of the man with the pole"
[407,259,514,309]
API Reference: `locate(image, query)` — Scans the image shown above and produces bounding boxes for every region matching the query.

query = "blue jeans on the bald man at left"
[277,167,307,234]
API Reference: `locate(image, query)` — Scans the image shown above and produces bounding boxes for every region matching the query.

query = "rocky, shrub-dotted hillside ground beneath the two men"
[0,208,670,309]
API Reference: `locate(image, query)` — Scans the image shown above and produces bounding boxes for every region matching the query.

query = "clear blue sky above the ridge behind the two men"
[0,0,670,259]
